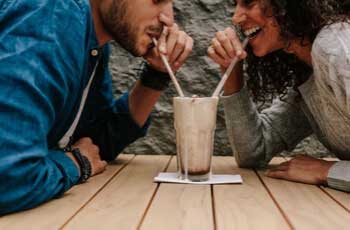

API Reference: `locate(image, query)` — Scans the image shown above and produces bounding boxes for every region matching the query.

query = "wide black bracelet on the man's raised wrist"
[140,63,171,91]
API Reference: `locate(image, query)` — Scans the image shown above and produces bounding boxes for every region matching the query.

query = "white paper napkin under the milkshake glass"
[154,173,243,184]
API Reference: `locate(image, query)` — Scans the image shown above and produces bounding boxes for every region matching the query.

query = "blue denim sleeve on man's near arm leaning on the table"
[0,0,87,214]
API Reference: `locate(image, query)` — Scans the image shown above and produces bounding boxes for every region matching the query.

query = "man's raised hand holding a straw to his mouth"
[144,23,193,72]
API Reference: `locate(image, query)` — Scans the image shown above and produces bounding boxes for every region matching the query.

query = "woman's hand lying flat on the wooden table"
[266,155,335,185]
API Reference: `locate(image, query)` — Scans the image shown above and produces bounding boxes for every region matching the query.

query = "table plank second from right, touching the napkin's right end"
[213,157,290,230]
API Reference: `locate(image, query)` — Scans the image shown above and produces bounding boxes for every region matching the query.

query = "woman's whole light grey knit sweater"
[222,23,350,191]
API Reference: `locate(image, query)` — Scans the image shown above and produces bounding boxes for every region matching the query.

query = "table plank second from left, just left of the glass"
[64,156,170,230]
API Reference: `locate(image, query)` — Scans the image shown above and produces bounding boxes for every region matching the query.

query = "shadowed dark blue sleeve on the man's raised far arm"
[73,45,150,161]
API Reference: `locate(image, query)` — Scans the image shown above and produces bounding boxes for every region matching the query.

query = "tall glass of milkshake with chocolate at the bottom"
[173,97,219,181]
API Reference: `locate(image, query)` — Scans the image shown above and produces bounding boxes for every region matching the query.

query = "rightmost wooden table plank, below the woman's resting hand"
[259,158,350,229]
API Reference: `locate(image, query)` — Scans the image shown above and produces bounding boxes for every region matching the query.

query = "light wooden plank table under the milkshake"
[0,155,350,230]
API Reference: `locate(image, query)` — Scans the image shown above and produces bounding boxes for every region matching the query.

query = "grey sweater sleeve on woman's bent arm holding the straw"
[222,87,312,167]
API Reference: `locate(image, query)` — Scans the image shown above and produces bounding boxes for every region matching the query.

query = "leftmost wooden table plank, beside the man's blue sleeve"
[0,155,134,230]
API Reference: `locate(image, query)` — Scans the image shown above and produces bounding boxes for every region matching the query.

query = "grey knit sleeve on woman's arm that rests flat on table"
[312,23,350,192]
